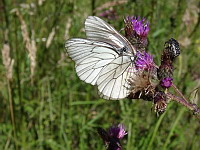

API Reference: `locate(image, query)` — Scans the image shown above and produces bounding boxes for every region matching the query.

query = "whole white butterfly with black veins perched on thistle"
[65,16,136,100]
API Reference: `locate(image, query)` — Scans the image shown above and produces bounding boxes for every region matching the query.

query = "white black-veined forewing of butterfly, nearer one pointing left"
[65,38,118,85]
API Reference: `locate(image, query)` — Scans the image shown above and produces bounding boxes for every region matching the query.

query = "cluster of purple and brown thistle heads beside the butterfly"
[124,16,184,113]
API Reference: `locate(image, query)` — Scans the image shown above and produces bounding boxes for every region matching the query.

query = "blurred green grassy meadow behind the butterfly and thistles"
[0,0,200,150]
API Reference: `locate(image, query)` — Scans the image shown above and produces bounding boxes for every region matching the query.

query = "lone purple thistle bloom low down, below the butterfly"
[108,124,127,139]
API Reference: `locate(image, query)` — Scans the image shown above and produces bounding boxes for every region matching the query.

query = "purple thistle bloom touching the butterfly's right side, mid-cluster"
[135,51,154,70]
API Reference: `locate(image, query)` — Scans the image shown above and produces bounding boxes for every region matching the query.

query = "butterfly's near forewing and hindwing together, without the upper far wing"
[65,39,135,100]
